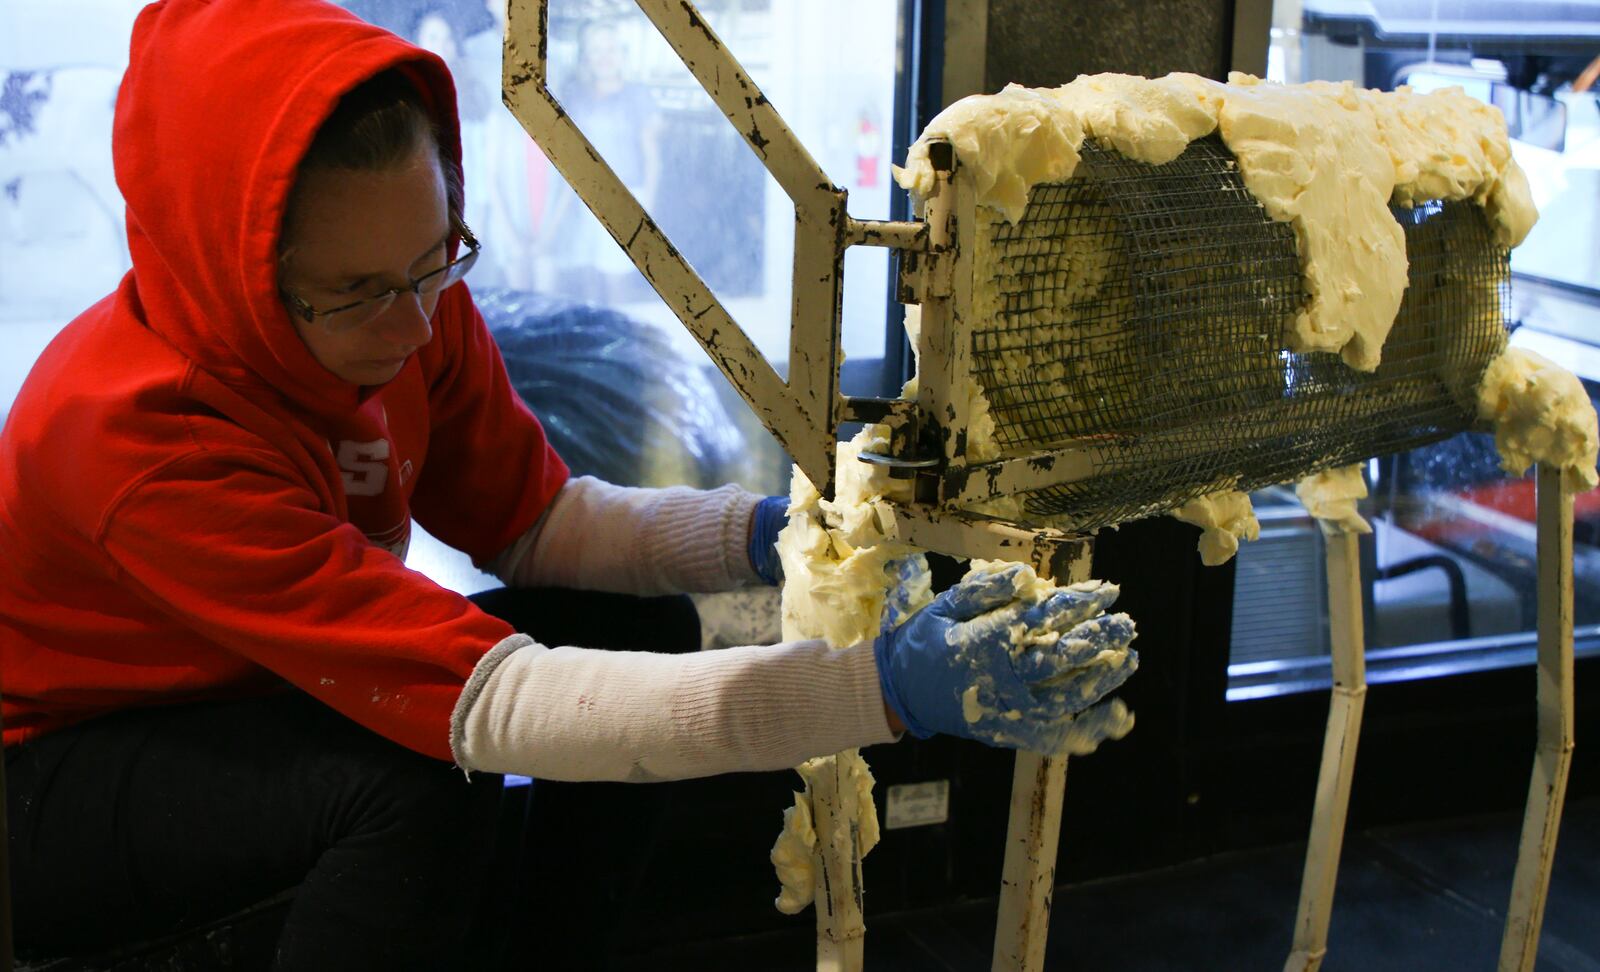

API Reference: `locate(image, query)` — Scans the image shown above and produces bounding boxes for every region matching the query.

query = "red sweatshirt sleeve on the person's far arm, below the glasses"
[411,286,568,566]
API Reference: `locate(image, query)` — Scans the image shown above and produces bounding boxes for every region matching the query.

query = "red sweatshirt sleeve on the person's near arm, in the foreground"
[101,452,512,759]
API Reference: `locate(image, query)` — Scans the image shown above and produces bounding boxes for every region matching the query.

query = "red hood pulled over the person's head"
[112,0,461,416]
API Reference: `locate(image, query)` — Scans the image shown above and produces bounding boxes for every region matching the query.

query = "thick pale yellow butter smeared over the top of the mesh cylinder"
[896,74,1538,371]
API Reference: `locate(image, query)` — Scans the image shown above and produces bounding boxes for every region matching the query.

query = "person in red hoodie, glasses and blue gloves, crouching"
[0,0,1133,969]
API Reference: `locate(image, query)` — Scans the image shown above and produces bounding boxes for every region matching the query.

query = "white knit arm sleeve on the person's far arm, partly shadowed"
[493,476,762,595]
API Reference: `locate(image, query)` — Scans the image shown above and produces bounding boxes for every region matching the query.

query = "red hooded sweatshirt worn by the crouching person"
[0,0,568,759]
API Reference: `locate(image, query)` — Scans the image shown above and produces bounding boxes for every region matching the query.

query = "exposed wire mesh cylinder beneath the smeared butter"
[971,136,1509,529]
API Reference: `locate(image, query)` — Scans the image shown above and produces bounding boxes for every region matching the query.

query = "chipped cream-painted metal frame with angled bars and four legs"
[502,0,1573,972]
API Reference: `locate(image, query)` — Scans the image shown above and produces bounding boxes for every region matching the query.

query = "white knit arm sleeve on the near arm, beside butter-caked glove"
[450,635,894,782]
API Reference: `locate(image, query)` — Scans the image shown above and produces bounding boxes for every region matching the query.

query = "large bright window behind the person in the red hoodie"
[0,0,901,588]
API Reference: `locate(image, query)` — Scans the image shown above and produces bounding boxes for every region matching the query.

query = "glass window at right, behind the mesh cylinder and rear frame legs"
[1229,0,1600,699]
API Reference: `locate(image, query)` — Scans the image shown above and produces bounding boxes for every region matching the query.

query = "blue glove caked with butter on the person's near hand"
[874,564,1139,753]
